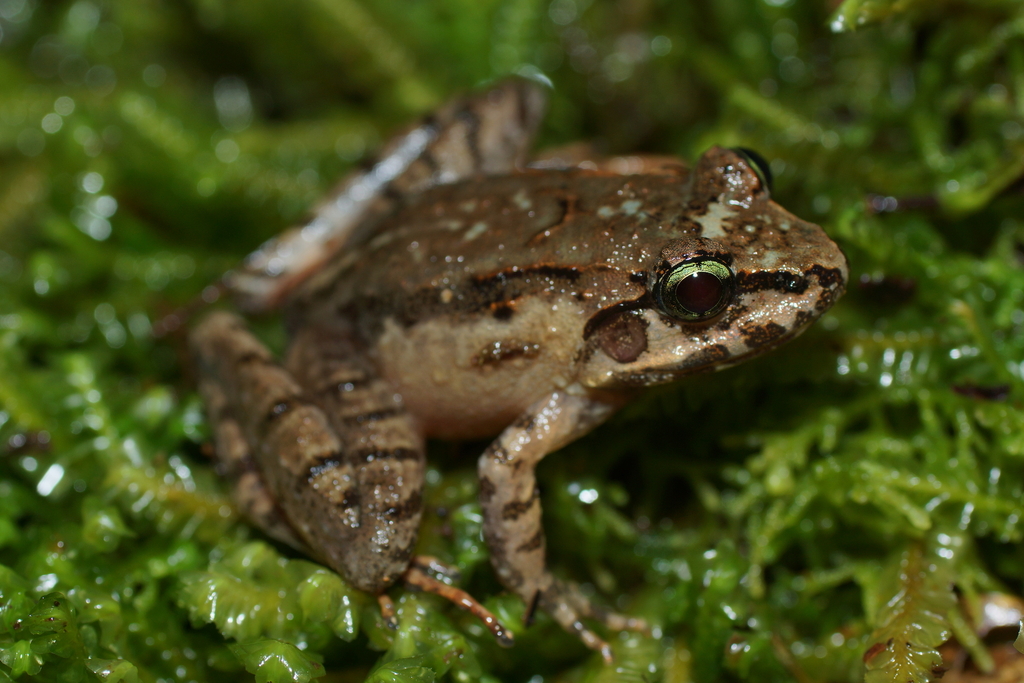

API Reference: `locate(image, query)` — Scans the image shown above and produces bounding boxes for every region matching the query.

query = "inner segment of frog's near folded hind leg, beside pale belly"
[286,324,425,582]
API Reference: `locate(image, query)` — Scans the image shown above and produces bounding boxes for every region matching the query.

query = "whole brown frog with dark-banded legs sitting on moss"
[190,80,847,657]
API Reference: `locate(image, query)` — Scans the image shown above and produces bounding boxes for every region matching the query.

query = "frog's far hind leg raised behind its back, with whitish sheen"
[224,78,547,310]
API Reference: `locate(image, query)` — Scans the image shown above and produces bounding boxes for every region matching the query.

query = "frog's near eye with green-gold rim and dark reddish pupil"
[654,258,734,323]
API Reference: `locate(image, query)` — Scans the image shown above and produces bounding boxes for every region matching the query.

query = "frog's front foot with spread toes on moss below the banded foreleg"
[525,579,649,664]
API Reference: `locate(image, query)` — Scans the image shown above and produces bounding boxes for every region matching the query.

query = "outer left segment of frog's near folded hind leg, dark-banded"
[190,312,408,593]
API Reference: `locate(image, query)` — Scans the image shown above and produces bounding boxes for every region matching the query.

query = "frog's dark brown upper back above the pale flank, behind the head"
[297,171,698,325]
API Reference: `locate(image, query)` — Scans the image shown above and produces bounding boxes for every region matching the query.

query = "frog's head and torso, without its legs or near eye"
[293,148,846,437]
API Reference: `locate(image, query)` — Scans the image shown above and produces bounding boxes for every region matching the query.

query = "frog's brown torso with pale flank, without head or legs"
[295,170,687,437]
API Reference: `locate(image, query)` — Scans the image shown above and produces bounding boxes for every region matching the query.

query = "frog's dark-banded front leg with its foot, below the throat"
[479,390,643,660]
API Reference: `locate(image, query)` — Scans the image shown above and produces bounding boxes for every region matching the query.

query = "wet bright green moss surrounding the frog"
[0,0,1024,683]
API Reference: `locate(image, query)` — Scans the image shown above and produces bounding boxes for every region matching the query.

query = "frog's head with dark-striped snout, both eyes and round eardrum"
[585,147,849,386]
